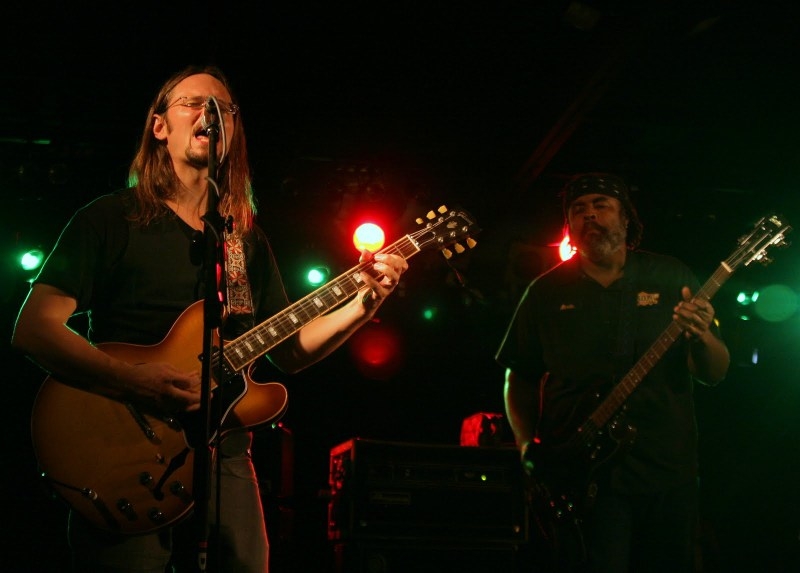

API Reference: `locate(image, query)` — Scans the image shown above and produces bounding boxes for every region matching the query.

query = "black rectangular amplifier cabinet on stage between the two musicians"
[328,438,528,544]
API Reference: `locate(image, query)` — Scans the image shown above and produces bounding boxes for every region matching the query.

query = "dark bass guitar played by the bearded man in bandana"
[525,215,791,547]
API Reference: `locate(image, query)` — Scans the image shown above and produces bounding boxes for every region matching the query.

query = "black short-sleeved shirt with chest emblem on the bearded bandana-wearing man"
[496,251,716,492]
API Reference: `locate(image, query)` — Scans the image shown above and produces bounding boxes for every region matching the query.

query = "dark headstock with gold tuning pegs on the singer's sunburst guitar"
[409,205,480,259]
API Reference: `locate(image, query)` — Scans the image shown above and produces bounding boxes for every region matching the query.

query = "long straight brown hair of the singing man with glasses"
[128,66,256,233]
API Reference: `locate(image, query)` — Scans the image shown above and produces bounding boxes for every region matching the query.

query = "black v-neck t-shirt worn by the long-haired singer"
[36,189,288,344]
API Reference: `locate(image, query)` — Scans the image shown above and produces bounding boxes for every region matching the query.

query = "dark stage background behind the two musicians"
[0,0,800,573]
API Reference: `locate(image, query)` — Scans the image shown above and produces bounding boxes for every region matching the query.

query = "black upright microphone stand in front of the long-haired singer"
[193,121,224,571]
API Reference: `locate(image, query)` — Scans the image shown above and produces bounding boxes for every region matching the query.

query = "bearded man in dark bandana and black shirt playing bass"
[496,172,730,573]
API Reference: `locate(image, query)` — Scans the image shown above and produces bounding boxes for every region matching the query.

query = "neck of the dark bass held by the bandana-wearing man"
[588,263,733,430]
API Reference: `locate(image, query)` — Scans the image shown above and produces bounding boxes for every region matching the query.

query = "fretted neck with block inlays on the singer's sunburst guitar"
[224,235,420,371]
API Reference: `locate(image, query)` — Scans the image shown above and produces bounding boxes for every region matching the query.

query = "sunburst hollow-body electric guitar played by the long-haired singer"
[31,207,479,534]
